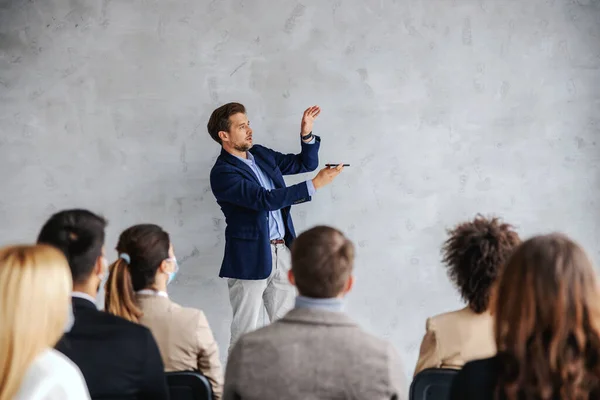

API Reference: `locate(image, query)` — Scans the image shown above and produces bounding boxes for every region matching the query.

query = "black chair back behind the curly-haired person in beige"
[409,368,458,400]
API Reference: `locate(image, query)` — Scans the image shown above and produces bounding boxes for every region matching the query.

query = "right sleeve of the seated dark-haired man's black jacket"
[139,330,169,400]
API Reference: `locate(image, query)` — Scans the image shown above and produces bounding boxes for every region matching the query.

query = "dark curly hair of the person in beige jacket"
[442,214,521,314]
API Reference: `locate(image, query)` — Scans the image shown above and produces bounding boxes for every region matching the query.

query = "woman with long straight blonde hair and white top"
[0,245,90,400]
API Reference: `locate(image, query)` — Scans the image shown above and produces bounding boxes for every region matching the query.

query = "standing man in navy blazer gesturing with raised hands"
[207,103,342,349]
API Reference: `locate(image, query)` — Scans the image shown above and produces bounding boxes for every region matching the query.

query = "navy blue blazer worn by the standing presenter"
[210,136,321,279]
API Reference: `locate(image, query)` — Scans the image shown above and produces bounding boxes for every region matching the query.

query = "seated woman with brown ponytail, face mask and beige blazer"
[105,224,223,399]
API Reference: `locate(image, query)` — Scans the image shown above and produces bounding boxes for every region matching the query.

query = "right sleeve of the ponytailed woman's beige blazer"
[196,311,223,400]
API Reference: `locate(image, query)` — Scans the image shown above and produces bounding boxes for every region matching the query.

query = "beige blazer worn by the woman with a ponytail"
[137,294,223,399]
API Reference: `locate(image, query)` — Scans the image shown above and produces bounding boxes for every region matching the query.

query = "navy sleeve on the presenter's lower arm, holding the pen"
[210,167,310,211]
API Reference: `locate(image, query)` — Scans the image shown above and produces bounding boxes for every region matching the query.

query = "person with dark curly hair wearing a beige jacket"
[415,215,520,375]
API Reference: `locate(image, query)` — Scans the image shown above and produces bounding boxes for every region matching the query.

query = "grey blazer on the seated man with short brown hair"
[223,308,408,400]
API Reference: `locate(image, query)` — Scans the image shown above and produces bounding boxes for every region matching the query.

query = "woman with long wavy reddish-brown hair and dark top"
[451,234,600,400]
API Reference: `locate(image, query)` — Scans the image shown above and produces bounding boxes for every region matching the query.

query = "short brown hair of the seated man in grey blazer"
[292,226,354,299]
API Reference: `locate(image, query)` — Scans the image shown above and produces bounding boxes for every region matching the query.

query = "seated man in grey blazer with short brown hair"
[223,226,408,400]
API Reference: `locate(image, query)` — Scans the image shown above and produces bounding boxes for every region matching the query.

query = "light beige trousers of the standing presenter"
[227,244,296,352]
